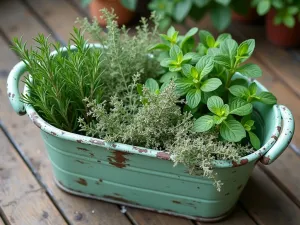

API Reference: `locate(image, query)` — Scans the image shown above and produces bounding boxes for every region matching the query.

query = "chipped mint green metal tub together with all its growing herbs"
[8,10,294,221]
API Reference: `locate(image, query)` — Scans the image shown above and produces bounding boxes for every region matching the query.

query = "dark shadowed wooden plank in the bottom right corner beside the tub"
[241,167,300,225]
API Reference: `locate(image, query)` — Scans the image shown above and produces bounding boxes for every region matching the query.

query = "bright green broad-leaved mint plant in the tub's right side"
[149,27,277,149]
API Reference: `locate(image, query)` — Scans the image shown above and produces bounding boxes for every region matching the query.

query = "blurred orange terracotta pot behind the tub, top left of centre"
[89,0,135,26]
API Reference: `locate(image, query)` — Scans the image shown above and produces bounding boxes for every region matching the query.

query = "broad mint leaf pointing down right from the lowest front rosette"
[220,119,246,142]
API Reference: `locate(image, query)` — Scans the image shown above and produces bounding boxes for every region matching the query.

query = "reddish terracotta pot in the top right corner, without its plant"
[266,9,300,47]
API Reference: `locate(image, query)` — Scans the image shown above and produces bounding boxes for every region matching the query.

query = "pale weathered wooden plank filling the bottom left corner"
[0,125,66,224]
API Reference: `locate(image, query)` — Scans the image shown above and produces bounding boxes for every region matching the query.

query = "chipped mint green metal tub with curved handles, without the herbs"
[7,45,294,221]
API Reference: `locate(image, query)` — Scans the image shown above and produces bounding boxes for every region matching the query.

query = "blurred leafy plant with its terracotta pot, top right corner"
[252,0,300,47]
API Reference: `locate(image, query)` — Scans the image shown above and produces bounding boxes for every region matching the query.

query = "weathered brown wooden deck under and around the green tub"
[0,0,300,225]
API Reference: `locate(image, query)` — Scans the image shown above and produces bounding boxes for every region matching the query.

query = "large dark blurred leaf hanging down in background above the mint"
[210,5,231,31]
